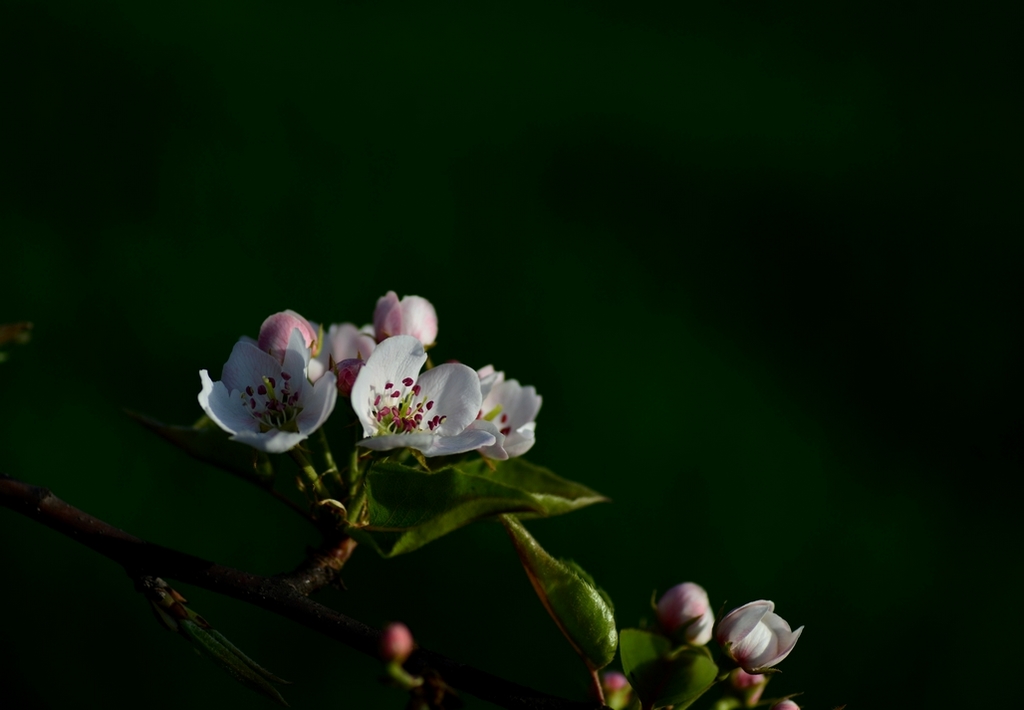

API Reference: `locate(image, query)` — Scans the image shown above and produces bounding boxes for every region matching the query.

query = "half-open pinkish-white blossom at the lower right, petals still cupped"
[716,599,804,673]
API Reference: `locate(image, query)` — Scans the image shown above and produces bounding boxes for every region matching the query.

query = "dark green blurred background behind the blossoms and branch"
[0,0,1024,710]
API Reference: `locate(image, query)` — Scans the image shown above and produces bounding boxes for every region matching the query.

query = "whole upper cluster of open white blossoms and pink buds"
[199,291,541,459]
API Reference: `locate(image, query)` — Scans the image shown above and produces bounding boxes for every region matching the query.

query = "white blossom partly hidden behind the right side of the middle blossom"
[473,365,542,460]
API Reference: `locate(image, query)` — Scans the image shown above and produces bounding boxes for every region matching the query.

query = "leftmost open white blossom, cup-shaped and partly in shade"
[193,328,338,454]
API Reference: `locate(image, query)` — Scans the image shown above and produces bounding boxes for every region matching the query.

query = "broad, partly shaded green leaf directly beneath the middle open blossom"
[350,463,544,557]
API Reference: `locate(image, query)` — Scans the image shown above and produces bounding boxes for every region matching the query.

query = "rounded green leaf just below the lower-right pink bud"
[618,629,718,710]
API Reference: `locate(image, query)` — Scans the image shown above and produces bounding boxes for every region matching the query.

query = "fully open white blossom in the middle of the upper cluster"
[352,335,496,456]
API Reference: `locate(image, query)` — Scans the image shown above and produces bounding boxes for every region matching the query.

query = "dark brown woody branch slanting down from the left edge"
[0,474,603,710]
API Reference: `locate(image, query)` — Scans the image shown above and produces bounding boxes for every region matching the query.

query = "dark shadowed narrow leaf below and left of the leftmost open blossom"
[127,412,273,487]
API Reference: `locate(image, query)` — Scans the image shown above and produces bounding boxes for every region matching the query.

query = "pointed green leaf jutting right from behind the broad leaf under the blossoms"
[457,457,608,518]
